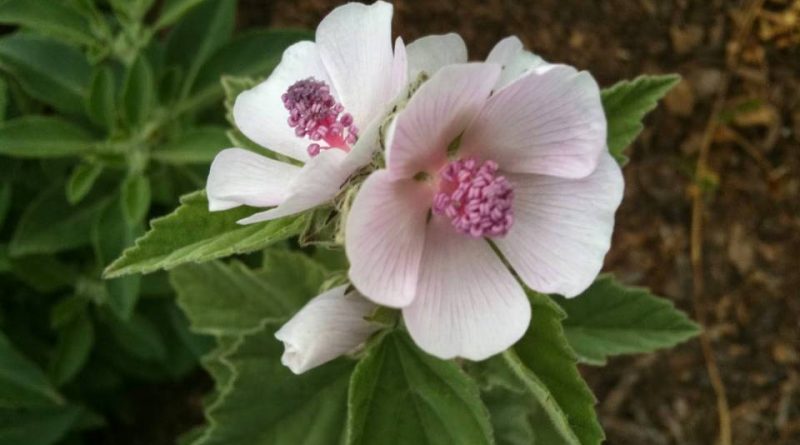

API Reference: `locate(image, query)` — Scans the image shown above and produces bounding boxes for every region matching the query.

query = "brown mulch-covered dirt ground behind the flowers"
[240,0,800,445]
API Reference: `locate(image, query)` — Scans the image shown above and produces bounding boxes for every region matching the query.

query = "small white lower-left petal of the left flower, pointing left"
[206,148,300,212]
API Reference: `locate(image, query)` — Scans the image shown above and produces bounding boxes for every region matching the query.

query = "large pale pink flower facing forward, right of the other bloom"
[345,56,623,360]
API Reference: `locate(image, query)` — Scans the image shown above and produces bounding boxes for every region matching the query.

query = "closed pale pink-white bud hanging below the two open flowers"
[275,286,380,374]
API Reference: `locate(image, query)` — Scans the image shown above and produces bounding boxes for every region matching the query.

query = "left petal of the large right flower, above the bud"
[345,170,433,307]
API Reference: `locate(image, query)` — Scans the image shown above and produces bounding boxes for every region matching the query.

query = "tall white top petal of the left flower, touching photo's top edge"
[316,1,393,128]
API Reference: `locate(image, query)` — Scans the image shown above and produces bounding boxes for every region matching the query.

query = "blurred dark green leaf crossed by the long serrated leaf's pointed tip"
[92,196,142,320]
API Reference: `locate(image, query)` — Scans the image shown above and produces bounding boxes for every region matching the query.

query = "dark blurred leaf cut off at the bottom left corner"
[0,405,83,445]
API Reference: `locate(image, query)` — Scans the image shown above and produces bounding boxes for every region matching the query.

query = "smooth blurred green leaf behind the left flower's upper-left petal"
[188,29,314,107]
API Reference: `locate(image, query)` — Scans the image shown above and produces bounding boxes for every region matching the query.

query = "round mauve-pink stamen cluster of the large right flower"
[433,158,514,238]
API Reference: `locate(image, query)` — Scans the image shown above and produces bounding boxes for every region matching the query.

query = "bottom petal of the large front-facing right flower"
[403,216,531,360]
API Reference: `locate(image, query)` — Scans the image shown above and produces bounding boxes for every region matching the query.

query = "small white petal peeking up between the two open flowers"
[406,33,467,81]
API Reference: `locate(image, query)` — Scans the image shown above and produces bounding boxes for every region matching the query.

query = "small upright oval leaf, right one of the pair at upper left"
[122,55,156,127]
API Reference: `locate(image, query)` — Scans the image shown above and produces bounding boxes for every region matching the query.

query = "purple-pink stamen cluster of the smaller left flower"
[281,77,358,156]
